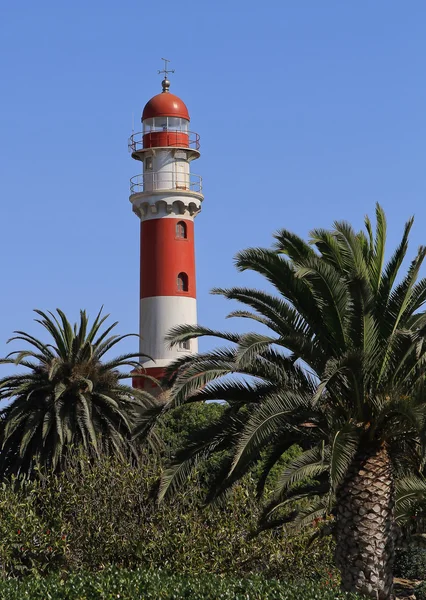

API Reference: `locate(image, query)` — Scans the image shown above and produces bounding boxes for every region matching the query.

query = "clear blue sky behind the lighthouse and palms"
[0,0,426,372]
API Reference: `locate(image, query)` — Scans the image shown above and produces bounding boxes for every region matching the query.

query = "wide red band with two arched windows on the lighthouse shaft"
[140,218,196,298]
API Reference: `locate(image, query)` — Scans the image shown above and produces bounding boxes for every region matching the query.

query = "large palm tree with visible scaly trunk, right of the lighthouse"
[151,206,426,599]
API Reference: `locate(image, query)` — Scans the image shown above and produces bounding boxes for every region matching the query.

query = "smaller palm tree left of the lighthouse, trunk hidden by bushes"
[0,309,155,477]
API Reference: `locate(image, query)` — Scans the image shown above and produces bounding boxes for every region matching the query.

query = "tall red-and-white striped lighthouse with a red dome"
[129,59,203,387]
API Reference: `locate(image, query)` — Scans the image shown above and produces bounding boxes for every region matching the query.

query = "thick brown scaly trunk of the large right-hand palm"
[336,445,395,600]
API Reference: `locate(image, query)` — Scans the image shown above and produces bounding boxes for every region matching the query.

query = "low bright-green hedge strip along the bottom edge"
[0,569,368,600]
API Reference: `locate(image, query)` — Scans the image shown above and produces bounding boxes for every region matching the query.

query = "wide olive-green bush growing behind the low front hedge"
[0,455,334,580]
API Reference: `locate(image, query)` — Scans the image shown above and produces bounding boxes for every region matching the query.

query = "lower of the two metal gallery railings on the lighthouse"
[130,171,203,194]
